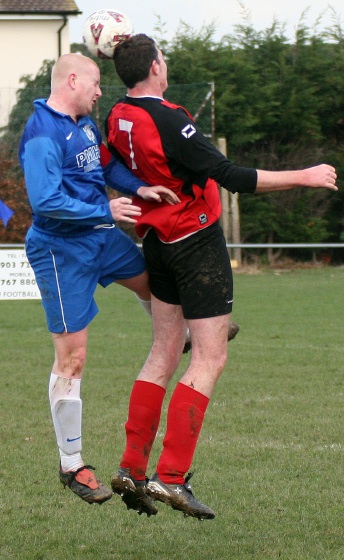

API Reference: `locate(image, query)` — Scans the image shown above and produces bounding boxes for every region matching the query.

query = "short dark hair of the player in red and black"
[113,33,159,88]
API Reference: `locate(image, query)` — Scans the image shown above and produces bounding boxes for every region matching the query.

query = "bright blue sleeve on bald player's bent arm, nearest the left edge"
[22,136,114,225]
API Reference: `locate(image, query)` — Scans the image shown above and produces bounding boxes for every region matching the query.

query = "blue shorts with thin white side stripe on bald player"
[26,227,146,333]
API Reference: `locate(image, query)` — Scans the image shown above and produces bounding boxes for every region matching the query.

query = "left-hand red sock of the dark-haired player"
[121,381,166,480]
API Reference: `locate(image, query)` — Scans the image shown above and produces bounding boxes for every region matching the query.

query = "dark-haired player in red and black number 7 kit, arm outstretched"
[107,34,337,519]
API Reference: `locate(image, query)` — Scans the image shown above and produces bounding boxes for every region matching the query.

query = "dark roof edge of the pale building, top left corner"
[0,0,82,15]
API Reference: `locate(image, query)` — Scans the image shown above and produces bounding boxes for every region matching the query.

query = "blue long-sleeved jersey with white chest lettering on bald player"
[19,99,144,237]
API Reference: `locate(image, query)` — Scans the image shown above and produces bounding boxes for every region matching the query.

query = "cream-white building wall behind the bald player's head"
[0,16,70,127]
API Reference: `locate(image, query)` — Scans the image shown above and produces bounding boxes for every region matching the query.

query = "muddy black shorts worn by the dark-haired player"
[143,222,233,319]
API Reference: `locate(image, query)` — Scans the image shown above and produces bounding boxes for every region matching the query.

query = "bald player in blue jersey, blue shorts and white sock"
[19,54,179,504]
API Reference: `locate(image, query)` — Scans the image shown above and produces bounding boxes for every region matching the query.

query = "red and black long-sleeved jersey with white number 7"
[106,97,257,243]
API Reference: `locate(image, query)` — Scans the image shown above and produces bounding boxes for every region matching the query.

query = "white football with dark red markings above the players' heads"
[83,8,134,59]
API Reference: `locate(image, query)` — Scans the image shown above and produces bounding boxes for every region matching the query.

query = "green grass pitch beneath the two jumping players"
[0,268,344,560]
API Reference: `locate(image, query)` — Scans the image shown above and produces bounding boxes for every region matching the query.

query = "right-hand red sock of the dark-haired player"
[157,383,209,484]
